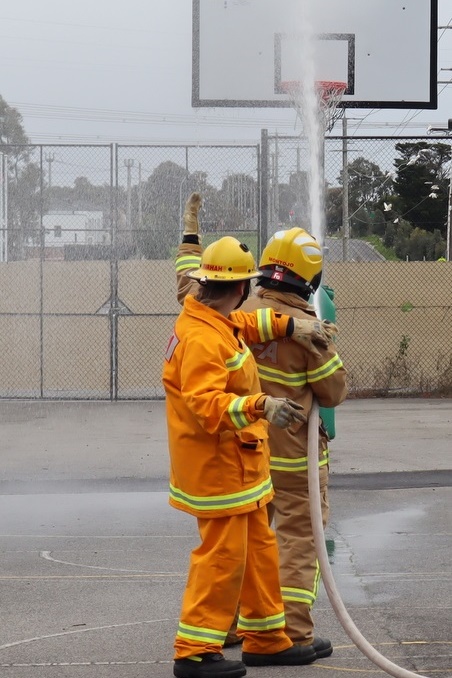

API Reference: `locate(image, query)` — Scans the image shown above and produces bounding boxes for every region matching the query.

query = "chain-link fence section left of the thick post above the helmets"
[0,145,259,399]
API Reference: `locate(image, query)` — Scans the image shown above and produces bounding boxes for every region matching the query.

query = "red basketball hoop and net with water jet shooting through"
[281,80,347,132]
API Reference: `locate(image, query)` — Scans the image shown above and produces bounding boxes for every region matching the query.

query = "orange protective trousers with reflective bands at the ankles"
[174,506,292,659]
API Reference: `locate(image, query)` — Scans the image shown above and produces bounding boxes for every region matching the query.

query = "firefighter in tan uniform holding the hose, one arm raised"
[176,196,347,663]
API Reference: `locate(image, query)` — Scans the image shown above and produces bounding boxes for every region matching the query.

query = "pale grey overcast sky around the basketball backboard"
[0,0,452,143]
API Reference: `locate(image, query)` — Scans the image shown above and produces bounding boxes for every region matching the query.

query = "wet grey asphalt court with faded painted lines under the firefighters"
[0,400,452,678]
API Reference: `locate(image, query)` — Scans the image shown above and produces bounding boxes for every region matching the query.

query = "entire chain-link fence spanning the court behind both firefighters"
[0,135,452,399]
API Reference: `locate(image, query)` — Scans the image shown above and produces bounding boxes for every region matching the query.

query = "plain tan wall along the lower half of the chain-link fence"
[0,261,452,398]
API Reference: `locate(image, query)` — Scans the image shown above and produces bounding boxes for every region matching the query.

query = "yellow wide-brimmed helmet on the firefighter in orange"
[187,235,262,283]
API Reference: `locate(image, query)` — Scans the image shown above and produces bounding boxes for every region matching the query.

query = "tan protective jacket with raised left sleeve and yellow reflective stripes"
[176,244,347,486]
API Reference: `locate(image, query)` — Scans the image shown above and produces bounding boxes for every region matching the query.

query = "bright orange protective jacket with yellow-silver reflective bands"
[163,292,290,518]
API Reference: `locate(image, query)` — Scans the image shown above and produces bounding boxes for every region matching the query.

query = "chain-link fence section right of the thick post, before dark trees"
[262,135,452,395]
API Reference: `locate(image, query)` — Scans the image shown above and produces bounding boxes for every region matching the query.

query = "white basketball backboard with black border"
[192,0,438,109]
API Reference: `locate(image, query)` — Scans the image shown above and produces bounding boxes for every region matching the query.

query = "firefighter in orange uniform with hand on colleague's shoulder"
[163,207,336,678]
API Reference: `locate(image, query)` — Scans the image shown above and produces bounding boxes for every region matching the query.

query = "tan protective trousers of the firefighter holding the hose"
[268,466,329,645]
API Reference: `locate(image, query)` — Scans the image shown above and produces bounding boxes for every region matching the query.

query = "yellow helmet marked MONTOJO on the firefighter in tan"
[259,228,323,294]
